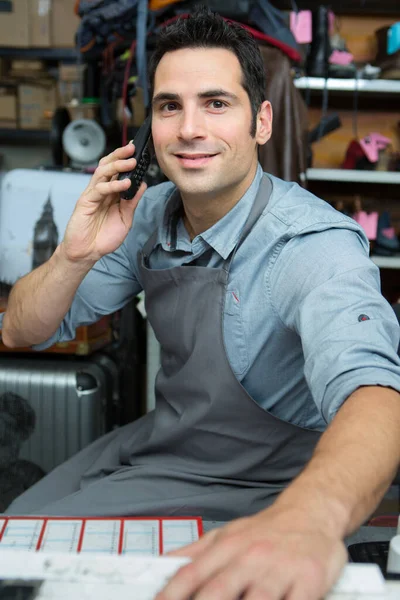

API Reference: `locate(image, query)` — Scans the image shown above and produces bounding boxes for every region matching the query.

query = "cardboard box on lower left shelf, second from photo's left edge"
[18,81,57,129]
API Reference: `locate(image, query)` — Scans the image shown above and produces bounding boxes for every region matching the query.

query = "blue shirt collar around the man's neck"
[158,164,263,260]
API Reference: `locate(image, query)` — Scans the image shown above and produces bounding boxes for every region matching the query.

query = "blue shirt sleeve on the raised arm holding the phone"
[0,239,141,350]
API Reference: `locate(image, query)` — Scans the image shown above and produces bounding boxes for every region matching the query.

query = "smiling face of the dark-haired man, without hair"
[152,48,270,202]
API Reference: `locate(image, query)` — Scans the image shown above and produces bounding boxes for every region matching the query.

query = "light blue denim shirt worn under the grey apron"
[6,166,400,430]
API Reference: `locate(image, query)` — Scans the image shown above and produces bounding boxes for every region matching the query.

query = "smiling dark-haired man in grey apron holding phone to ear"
[3,5,400,600]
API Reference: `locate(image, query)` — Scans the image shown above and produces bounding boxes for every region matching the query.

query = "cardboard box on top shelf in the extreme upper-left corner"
[0,0,31,48]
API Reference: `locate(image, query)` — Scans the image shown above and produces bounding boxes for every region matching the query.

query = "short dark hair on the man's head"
[149,6,266,137]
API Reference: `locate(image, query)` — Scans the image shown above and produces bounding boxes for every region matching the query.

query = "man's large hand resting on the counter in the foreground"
[156,507,347,600]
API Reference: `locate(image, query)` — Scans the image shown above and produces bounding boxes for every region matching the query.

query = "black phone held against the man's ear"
[118,115,154,200]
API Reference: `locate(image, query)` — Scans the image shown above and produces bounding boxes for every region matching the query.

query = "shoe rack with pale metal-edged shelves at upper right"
[294,9,400,302]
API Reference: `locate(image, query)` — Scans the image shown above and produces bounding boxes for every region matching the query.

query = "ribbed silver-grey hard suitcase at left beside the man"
[0,356,111,473]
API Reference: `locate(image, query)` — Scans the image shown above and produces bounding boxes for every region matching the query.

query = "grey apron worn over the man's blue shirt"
[8,176,321,521]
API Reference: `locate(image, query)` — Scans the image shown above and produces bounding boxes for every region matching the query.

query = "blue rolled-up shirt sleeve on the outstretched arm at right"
[271,228,400,423]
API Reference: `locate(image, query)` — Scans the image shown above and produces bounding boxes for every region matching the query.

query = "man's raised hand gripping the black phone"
[62,143,146,263]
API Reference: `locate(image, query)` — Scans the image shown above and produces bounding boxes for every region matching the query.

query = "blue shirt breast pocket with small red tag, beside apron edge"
[224,289,249,376]
